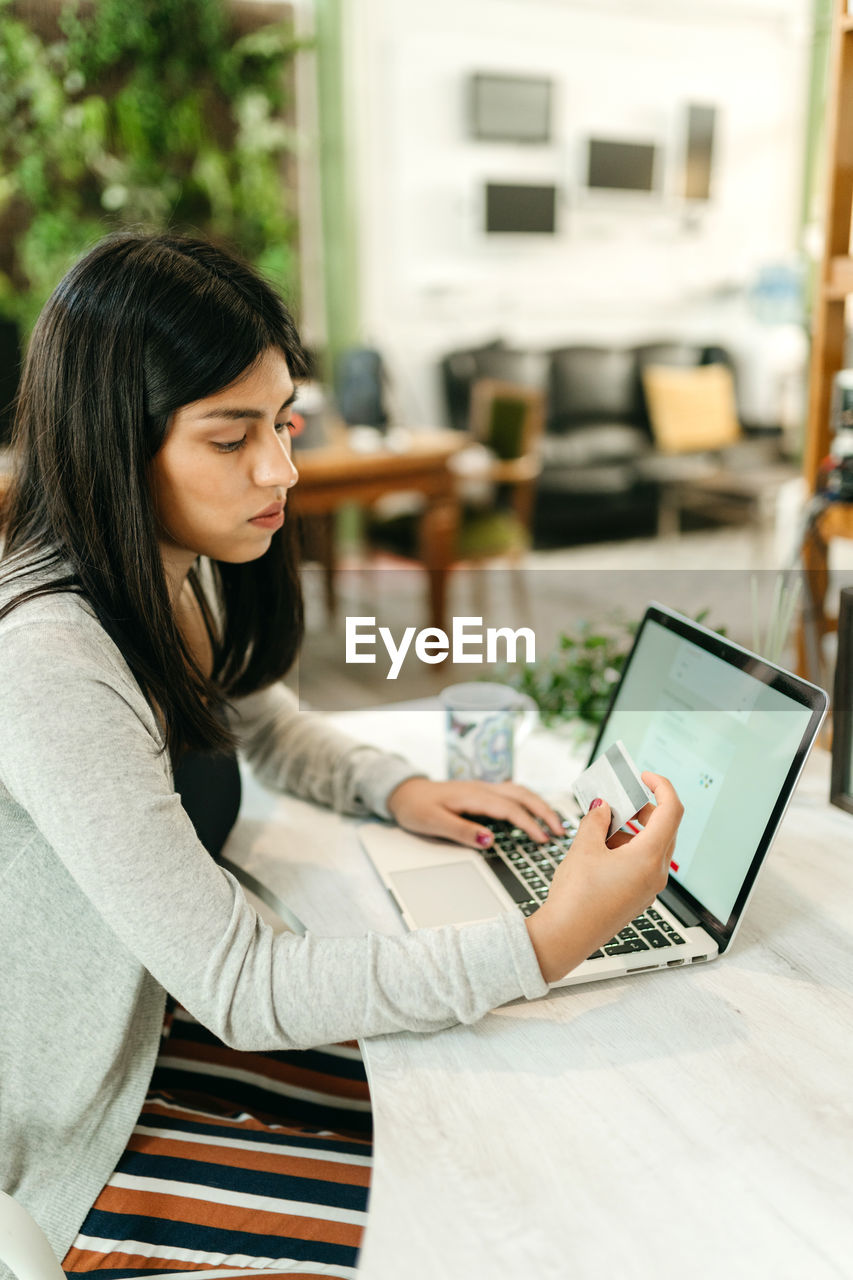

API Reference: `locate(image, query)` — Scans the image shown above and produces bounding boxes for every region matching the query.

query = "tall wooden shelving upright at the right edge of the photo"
[799,0,853,680]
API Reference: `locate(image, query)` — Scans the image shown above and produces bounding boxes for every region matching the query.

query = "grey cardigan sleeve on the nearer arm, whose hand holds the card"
[0,607,547,1050]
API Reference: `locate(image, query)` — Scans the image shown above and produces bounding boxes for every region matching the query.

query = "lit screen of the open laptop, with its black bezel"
[592,607,826,932]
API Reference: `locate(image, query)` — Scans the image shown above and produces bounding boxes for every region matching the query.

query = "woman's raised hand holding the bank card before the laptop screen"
[526,772,684,982]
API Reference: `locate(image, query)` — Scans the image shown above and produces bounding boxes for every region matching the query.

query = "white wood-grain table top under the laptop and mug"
[225,709,853,1280]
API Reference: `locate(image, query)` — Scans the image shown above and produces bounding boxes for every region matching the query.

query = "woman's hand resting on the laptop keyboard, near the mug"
[388,778,564,849]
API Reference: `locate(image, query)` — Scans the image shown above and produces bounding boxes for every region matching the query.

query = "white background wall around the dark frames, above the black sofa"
[346,0,811,422]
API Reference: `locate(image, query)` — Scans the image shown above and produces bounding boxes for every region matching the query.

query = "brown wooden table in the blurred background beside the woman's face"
[288,431,470,628]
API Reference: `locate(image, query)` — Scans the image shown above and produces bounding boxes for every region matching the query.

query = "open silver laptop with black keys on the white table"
[359,603,829,986]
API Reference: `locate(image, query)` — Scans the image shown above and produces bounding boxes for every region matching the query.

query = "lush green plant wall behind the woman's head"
[0,0,301,333]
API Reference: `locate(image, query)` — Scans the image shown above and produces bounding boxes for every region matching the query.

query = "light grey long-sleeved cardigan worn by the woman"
[0,547,547,1275]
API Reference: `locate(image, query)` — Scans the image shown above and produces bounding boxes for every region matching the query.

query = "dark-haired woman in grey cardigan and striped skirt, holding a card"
[0,236,681,1280]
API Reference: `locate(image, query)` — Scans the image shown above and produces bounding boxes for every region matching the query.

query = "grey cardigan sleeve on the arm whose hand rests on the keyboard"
[229,684,420,818]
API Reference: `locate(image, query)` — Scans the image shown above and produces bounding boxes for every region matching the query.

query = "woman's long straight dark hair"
[0,233,309,759]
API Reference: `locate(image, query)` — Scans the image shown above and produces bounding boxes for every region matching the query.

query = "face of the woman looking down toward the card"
[151,347,297,585]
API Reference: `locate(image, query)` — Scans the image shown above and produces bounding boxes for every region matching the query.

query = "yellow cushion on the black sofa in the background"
[643,365,740,453]
